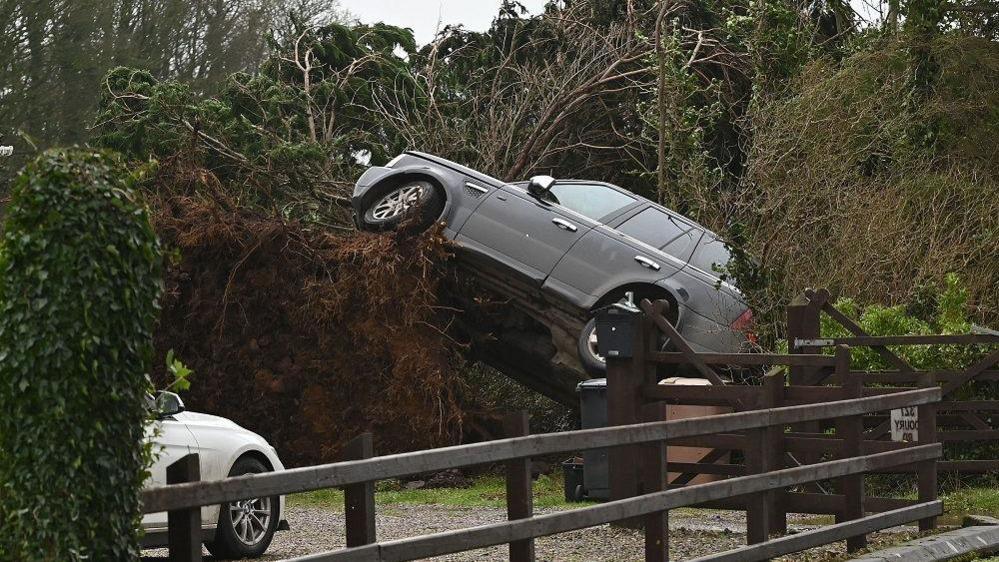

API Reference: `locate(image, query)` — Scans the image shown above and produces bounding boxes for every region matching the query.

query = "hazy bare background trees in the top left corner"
[0,0,345,192]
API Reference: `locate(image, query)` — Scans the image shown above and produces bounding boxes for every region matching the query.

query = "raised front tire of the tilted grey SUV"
[357,178,444,231]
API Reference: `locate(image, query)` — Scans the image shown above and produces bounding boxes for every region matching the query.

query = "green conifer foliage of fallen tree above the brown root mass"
[95,22,416,224]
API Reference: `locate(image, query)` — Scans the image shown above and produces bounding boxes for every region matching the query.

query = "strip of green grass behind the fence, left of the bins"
[288,472,580,510]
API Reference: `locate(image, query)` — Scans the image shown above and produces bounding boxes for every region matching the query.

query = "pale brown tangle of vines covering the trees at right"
[728,36,999,323]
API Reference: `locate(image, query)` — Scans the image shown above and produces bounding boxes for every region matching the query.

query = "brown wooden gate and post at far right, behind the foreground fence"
[787,289,999,473]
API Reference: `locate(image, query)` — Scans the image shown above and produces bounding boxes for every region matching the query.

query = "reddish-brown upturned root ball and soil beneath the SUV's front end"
[153,191,467,465]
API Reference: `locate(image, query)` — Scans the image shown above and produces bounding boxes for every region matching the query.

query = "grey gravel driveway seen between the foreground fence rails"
[144,504,920,562]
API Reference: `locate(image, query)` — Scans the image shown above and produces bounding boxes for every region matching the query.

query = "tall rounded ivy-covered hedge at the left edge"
[0,150,162,561]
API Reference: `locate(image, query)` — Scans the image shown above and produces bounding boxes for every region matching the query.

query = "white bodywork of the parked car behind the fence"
[142,411,285,531]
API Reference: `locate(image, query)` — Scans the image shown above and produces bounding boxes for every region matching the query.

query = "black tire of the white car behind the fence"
[205,457,281,559]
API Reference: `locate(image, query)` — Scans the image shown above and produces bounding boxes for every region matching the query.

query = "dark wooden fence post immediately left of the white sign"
[836,345,867,552]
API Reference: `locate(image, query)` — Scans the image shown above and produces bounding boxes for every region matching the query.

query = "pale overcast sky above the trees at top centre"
[340,0,546,45]
